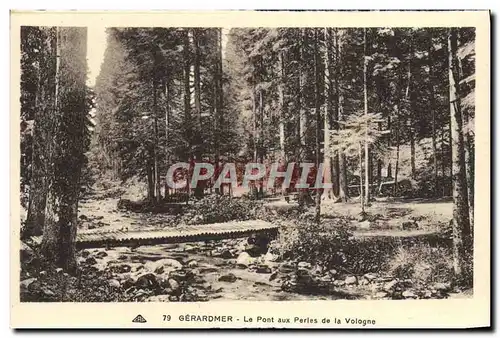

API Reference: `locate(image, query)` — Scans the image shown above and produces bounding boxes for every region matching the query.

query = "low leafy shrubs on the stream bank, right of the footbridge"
[278,217,458,283]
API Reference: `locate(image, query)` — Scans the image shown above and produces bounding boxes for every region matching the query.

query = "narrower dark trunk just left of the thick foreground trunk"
[22,28,59,237]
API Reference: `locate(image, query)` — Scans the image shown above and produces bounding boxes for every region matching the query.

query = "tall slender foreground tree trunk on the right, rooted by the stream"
[448,28,472,282]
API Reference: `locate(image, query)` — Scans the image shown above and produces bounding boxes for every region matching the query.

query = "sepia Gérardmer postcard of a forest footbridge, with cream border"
[10,11,491,329]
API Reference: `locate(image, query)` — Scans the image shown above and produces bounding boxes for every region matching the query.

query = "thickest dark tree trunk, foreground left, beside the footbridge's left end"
[42,27,87,272]
